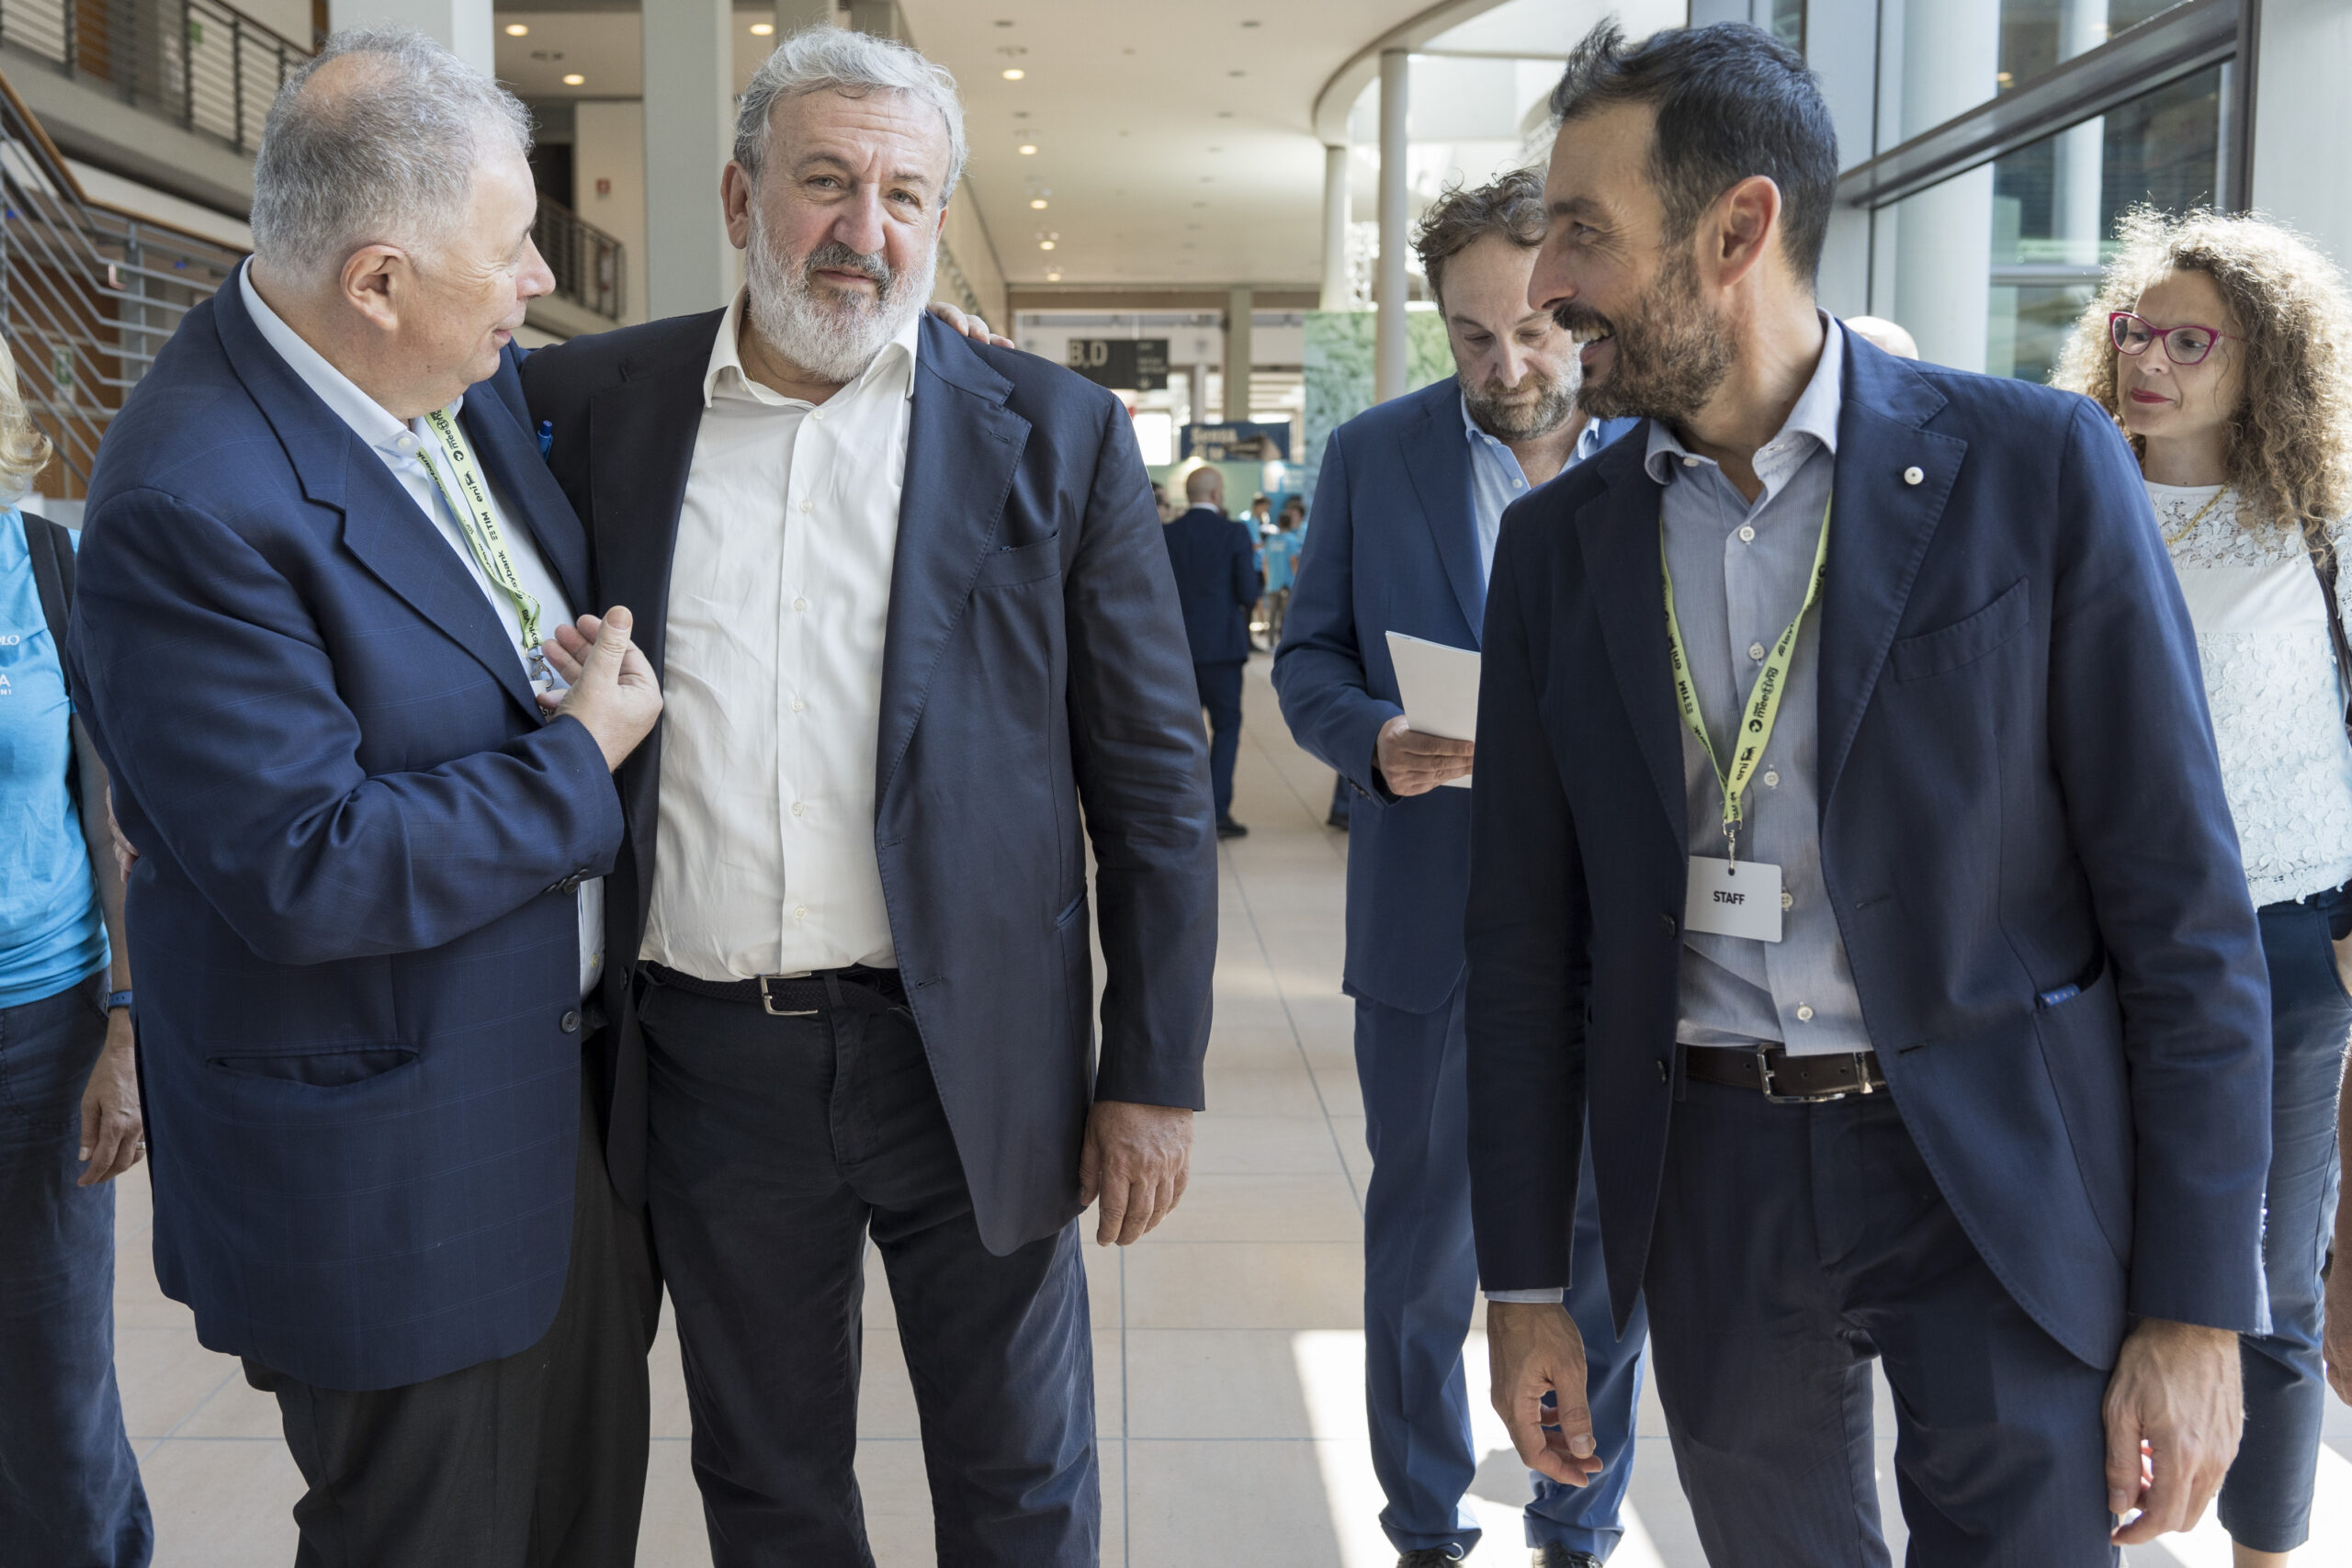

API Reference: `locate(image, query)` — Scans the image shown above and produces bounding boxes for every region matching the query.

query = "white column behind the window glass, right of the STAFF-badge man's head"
[1894,0,2002,371]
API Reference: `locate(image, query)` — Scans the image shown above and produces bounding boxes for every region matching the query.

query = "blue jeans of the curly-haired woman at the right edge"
[2221,891,2352,1551]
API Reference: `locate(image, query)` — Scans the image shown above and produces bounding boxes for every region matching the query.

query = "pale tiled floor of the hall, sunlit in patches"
[118,659,2352,1568]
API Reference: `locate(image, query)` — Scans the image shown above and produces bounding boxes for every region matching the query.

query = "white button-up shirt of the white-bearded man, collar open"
[639,291,920,980]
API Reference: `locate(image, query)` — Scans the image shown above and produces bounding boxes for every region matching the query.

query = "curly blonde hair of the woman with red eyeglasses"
[2051,207,2352,541]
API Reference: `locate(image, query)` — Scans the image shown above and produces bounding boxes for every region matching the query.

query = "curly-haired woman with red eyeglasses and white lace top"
[2053,211,2352,1568]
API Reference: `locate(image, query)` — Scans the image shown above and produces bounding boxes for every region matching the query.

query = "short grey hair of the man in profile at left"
[254,28,532,270]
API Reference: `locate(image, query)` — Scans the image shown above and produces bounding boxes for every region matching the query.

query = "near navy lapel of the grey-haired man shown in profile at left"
[211,271,541,724]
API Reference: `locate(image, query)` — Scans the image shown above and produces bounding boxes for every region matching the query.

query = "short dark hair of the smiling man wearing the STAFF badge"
[1553,21,1837,280]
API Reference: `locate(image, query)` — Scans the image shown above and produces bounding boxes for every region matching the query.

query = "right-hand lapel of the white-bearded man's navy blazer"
[875,315,1030,804]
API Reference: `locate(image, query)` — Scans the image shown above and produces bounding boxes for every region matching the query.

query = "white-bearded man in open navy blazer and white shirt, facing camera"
[522,26,1216,1568]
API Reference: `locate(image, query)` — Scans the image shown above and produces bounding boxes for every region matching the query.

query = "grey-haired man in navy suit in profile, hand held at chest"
[71,33,661,1568]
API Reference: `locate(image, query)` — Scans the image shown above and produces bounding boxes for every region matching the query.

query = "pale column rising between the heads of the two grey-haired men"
[639,0,736,317]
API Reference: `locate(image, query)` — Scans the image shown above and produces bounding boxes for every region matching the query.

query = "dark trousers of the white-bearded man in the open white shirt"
[639,983,1103,1568]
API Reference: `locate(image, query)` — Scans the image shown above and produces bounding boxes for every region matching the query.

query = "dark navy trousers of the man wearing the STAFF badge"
[1644,1084,2117,1568]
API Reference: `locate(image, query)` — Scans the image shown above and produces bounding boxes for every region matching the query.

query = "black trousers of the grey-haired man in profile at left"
[244,1072,661,1568]
